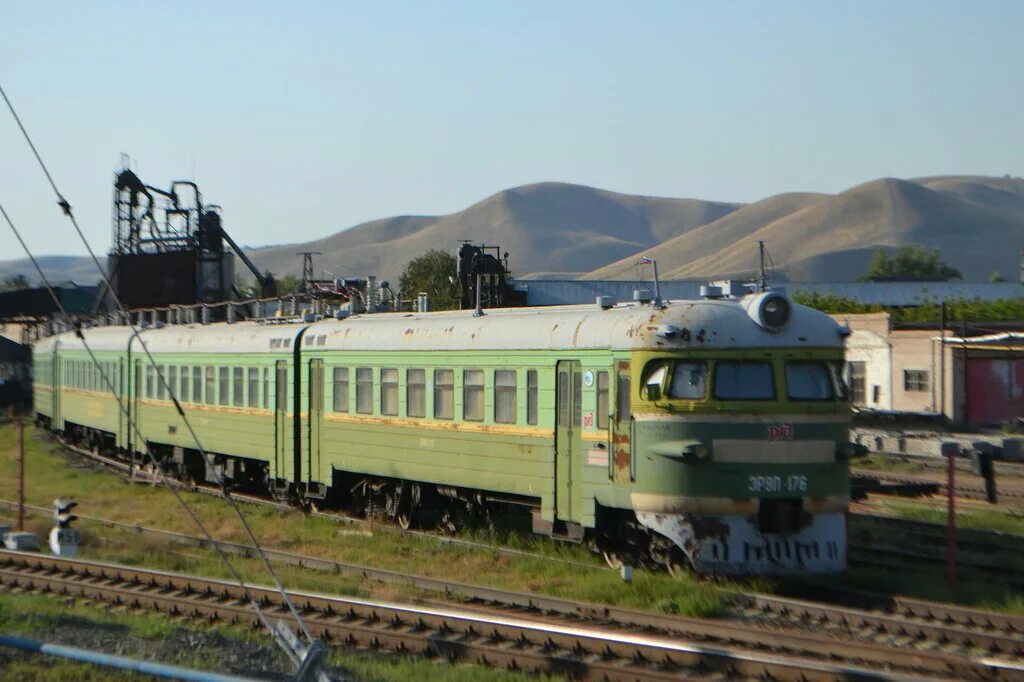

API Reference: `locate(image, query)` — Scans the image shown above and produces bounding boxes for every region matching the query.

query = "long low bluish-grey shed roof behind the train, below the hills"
[515,280,1024,307]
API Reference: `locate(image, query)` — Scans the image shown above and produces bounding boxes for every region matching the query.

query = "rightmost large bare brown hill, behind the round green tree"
[666,179,1024,281]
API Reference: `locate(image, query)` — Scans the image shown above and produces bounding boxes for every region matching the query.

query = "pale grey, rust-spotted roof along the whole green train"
[36,295,844,354]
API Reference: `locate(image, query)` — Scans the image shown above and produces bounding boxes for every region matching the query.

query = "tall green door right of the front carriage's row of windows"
[555,360,583,521]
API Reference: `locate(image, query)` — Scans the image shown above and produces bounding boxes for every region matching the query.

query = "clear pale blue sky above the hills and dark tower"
[0,0,1024,258]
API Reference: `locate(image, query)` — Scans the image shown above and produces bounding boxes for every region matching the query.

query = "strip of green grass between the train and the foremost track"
[0,426,743,615]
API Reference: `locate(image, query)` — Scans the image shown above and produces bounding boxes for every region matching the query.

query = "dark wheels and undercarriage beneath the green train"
[41,419,845,574]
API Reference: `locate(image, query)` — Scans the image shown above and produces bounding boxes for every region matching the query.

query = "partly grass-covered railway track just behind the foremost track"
[4,503,1024,679]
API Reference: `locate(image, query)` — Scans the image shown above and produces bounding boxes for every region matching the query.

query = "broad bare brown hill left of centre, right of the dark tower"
[243,182,738,280]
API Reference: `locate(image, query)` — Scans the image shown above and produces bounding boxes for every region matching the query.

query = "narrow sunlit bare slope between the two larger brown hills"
[581,193,827,280]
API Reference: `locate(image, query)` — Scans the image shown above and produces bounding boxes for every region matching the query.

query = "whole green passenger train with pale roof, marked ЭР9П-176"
[34,289,855,574]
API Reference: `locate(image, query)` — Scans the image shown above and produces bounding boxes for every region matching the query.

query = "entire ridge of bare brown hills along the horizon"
[0,175,1024,284]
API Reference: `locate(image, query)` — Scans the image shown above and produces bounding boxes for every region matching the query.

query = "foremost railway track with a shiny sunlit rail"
[0,551,1024,680]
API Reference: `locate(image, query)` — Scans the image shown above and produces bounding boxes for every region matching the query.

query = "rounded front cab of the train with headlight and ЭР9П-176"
[630,291,850,574]
